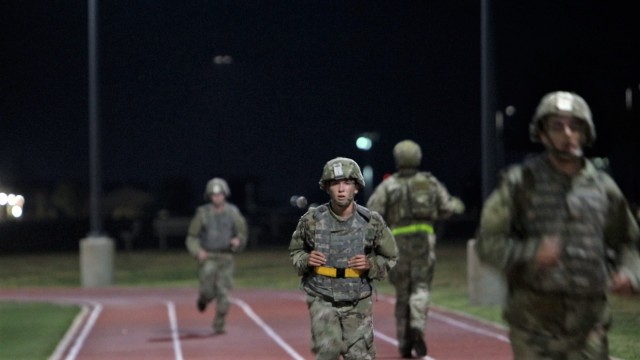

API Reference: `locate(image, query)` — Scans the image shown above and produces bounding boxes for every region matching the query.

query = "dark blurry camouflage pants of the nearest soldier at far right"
[505,289,611,360]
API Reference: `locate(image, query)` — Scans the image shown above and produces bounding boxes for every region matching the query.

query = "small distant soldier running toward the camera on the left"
[186,178,248,334]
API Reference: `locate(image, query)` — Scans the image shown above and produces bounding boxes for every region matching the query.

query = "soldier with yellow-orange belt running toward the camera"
[289,157,398,360]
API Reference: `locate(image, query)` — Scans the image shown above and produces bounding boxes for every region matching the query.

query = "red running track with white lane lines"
[0,288,511,360]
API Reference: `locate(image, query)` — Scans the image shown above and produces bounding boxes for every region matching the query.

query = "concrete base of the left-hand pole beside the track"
[80,236,115,287]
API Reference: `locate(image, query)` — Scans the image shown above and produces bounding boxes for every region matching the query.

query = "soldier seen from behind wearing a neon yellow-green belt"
[367,140,464,358]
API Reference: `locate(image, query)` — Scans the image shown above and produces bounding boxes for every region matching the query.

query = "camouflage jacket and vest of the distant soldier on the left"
[186,202,249,256]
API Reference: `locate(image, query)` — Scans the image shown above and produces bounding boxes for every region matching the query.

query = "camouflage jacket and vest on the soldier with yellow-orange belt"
[289,204,398,301]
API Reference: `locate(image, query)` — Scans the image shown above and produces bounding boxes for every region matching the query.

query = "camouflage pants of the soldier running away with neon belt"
[389,234,436,349]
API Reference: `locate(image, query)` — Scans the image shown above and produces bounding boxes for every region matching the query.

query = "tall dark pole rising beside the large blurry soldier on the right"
[480,0,496,199]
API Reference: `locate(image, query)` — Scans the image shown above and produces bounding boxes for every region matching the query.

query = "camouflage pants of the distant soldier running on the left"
[200,254,234,330]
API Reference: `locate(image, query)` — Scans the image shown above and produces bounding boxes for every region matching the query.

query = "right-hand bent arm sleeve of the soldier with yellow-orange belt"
[369,212,398,280]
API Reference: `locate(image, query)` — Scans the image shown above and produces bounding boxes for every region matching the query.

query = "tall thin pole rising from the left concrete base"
[87,0,102,236]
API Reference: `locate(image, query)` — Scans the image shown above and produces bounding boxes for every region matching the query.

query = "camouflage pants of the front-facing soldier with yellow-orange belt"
[307,296,376,360]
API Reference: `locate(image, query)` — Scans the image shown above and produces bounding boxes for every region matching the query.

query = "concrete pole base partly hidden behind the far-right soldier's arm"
[467,239,507,305]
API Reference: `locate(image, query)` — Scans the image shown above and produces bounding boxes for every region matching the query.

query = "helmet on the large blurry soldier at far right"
[529,91,596,145]
